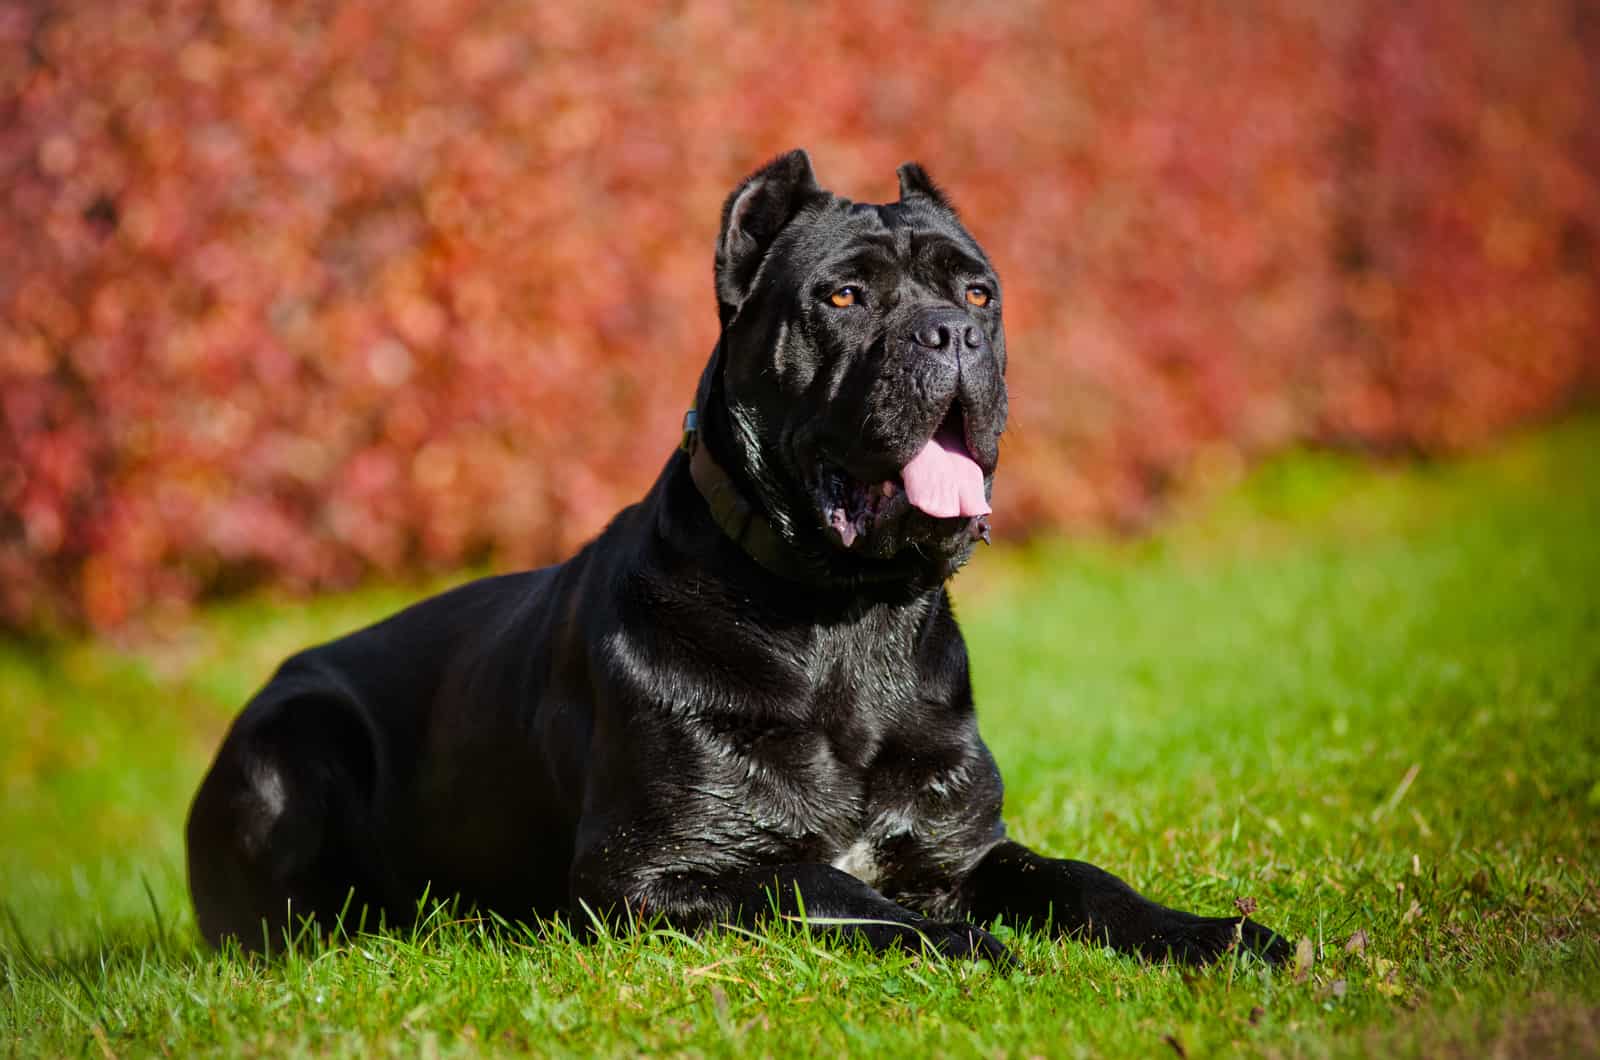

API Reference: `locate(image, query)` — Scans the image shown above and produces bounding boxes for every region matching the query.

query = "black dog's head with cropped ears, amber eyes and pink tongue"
[701,151,1006,581]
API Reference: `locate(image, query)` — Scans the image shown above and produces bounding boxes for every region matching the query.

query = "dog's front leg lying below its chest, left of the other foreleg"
[574,861,1011,964]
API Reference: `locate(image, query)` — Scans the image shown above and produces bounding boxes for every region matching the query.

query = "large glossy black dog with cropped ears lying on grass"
[189,151,1288,961]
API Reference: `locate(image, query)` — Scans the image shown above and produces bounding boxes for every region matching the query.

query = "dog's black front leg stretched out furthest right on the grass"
[965,841,1293,964]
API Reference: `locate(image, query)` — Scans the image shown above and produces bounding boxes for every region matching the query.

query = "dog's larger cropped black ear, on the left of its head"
[717,149,822,327]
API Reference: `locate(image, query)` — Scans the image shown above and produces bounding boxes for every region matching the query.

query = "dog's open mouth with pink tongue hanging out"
[818,407,992,552]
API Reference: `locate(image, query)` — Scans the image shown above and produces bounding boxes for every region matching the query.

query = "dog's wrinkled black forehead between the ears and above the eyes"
[790,197,992,277]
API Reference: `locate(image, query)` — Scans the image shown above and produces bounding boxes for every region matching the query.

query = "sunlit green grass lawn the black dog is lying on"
[0,418,1600,1057]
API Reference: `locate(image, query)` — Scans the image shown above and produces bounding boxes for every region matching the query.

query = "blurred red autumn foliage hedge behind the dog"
[0,0,1600,626]
